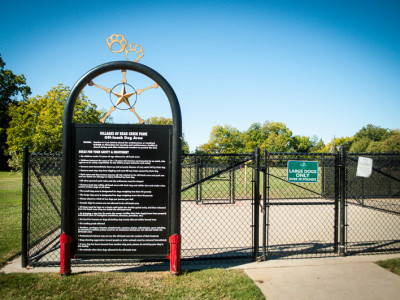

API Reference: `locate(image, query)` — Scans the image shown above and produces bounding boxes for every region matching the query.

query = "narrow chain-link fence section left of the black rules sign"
[26,153,61,265]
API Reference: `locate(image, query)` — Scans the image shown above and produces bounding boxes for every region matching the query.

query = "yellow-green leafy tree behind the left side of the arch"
[7,84,104,170]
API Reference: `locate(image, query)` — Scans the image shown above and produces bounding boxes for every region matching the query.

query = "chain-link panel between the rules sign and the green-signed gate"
[181,154,258,260]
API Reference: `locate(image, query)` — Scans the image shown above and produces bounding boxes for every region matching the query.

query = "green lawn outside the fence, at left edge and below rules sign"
[0,172,264,299]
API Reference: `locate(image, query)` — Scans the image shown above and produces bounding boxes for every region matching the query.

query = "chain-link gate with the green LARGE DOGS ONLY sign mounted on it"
[262,152,339,260]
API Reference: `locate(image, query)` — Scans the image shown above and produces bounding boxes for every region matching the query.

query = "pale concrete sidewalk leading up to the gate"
[236,254,400,300]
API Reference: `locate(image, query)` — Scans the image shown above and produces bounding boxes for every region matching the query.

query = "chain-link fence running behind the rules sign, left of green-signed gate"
[26,153,254,266]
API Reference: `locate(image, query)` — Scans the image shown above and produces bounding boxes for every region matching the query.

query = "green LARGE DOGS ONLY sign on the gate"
[288,160,318,182]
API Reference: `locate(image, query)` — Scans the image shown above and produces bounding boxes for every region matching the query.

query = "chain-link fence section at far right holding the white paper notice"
[345,154,400,254]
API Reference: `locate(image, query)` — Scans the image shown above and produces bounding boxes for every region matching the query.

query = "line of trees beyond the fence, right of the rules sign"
[196,121,400,153]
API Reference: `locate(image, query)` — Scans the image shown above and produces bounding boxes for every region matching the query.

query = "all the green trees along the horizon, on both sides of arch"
[0,55,400,170]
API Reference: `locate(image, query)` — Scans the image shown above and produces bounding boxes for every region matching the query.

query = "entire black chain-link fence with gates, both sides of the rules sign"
[22,151,400,266]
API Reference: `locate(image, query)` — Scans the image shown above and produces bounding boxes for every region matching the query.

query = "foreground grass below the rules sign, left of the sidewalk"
[0,269,264,299]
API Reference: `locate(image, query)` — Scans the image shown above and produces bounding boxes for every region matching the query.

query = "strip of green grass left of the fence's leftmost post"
[0,172,22,266]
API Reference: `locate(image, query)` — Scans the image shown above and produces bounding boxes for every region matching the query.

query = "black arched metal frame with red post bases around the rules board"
[60,61,182,274]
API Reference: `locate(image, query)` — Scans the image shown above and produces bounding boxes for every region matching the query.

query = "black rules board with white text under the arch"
[74,124,172,257]
